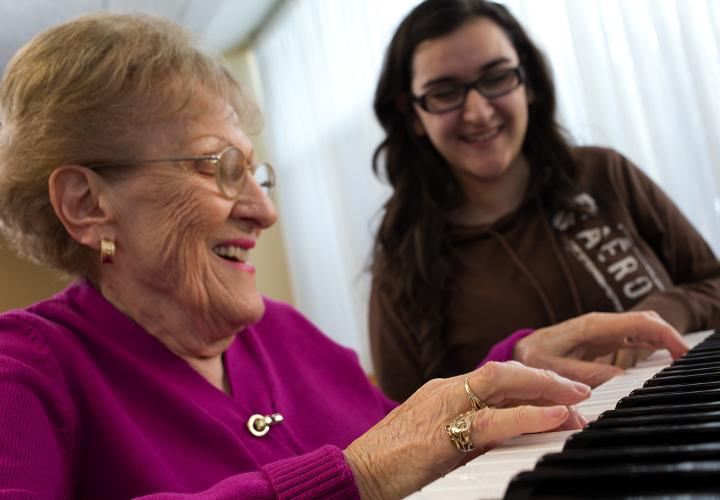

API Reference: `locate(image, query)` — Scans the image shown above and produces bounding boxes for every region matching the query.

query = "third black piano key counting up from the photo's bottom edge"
[563,422,720,450]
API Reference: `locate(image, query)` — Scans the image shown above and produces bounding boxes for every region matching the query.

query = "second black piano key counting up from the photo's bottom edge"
[535,443,720,468]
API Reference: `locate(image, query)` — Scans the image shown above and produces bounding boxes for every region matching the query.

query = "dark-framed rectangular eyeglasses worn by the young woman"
[413,66,525,114]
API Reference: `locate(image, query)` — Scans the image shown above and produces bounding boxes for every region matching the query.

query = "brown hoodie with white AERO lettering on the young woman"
[369,148,720,401]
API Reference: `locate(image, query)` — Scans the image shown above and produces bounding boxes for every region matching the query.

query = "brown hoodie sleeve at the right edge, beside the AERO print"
[614,150,720,333]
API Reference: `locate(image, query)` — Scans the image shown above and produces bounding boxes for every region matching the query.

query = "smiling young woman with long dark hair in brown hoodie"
[370,0,720,400]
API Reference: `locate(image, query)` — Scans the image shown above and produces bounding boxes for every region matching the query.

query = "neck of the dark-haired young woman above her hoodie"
[451,156,530,226]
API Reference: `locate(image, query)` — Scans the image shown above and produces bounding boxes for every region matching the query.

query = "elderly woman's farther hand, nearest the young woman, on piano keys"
[514,311,688,387]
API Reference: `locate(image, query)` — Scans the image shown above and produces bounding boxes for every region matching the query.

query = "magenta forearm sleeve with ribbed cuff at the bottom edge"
[136,446,360,500]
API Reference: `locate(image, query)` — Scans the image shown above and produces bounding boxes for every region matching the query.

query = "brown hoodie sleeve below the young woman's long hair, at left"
[368,285,426,401]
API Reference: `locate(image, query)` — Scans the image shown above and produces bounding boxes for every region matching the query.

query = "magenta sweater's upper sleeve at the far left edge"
[0,317,76,499]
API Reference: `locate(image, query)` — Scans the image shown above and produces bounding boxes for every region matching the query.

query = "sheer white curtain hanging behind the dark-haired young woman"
[253,0,720,370]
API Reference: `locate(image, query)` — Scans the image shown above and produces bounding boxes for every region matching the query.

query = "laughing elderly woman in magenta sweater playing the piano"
[0,14,685,499]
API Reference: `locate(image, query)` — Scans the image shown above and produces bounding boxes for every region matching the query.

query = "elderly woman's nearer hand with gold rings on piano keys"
[345,361,590,498]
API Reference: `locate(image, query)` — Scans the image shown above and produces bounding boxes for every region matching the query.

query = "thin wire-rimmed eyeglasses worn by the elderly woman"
[87,146,275,200]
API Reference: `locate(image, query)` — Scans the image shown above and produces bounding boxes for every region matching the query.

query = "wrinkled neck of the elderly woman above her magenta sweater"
[99,280,237,394]
